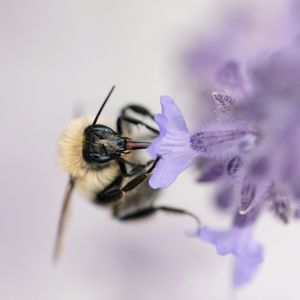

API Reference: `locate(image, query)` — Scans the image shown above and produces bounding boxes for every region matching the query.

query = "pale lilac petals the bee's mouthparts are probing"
[148,96,196,188]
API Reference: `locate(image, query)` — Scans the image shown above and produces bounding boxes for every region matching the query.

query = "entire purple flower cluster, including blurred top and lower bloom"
[149,0,300,286]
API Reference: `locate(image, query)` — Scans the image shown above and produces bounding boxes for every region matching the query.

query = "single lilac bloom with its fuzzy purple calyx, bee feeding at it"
[148,96,256,188]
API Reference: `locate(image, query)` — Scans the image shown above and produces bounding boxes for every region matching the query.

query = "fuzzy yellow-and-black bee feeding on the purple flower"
[54,86,199,260]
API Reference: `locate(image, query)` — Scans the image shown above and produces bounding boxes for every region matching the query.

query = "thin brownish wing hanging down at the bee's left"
[53,177,75,261]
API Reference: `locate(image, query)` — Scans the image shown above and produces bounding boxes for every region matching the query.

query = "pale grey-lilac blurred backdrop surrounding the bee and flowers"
[0,0,300,300]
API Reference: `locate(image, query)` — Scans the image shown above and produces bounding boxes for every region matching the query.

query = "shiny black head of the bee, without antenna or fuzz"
[82,124,127,164]
